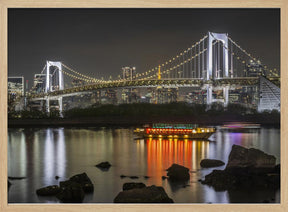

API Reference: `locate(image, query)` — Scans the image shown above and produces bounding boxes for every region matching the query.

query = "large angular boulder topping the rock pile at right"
[226,145,276,169]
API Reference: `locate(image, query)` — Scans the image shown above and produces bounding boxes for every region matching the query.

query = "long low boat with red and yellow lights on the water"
[134,123,216,139]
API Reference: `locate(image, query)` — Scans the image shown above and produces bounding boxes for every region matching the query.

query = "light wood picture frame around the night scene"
[0,0,288,212]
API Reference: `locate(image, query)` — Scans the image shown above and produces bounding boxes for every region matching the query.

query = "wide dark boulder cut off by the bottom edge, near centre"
[114,185,173,203]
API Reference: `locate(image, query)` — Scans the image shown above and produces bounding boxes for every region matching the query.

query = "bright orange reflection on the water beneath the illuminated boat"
[146,138,209,184]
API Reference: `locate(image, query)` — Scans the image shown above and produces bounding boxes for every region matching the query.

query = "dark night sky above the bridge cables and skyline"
[8,9,280,87]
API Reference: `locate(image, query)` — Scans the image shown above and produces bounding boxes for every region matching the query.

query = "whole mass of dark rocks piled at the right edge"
[201,145,280,191]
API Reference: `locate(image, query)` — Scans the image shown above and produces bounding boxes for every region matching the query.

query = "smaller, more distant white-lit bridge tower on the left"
[45,61,64,117]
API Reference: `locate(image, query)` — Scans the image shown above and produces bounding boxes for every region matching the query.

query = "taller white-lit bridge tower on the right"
[203,32,229,107]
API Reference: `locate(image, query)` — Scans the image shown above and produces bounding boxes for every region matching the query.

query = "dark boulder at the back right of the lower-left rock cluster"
[60,172,94,193]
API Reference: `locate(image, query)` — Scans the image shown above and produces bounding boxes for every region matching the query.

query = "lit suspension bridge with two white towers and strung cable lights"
[28,32,280,113]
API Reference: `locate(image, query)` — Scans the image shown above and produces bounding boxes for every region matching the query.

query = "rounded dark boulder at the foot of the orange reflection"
[166,164,190,181]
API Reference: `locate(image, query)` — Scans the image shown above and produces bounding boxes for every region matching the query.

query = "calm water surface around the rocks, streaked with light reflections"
[8,128,280,203]
